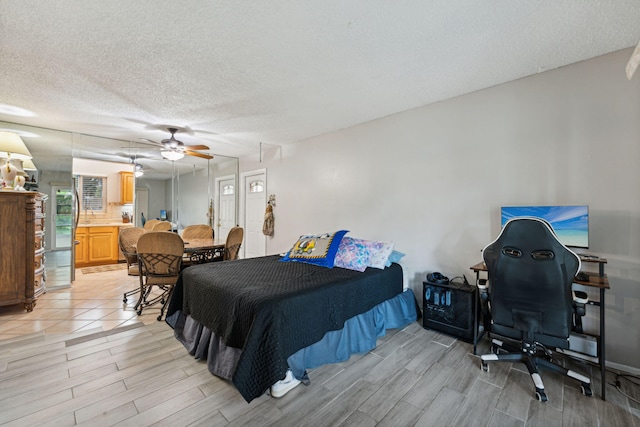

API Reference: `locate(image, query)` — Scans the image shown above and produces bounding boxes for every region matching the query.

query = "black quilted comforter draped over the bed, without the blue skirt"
[167,256,402,402]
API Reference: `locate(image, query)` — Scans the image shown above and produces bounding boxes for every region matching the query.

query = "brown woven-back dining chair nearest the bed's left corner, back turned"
[134,231,184,320]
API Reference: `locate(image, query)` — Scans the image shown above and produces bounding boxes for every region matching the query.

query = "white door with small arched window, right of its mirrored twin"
[242,171,267,258]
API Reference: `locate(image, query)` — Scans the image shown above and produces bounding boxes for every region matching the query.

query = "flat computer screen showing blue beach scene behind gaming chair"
[501,205,589,249]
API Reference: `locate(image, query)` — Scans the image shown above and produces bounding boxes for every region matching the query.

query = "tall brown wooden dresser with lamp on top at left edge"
[0,191,47,311]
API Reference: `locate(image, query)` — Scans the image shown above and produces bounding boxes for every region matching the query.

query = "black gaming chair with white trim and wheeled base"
[480,218,591,402]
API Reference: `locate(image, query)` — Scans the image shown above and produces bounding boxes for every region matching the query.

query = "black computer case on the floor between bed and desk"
[422,281,477,342]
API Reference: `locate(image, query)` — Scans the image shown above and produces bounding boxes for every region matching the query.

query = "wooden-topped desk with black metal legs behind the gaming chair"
[471,256,610,400]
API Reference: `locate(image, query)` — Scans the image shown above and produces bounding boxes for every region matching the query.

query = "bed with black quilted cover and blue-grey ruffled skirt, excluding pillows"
[167,255,416,402]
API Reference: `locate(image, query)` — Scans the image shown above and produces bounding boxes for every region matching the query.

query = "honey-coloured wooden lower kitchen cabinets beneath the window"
[76,226,119,268]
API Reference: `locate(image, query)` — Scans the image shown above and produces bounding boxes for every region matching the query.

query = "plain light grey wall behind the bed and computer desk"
[240,50,640,368]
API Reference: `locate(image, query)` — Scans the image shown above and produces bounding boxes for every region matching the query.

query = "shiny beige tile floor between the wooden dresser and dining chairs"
[0,254,160,340]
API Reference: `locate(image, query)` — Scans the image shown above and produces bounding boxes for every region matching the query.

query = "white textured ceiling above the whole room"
[0,0,640,174]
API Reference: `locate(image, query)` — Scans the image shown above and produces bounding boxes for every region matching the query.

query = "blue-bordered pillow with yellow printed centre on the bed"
[280,230,348,268]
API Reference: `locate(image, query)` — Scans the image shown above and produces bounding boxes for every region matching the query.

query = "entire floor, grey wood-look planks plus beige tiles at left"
[0,264,640,427]
